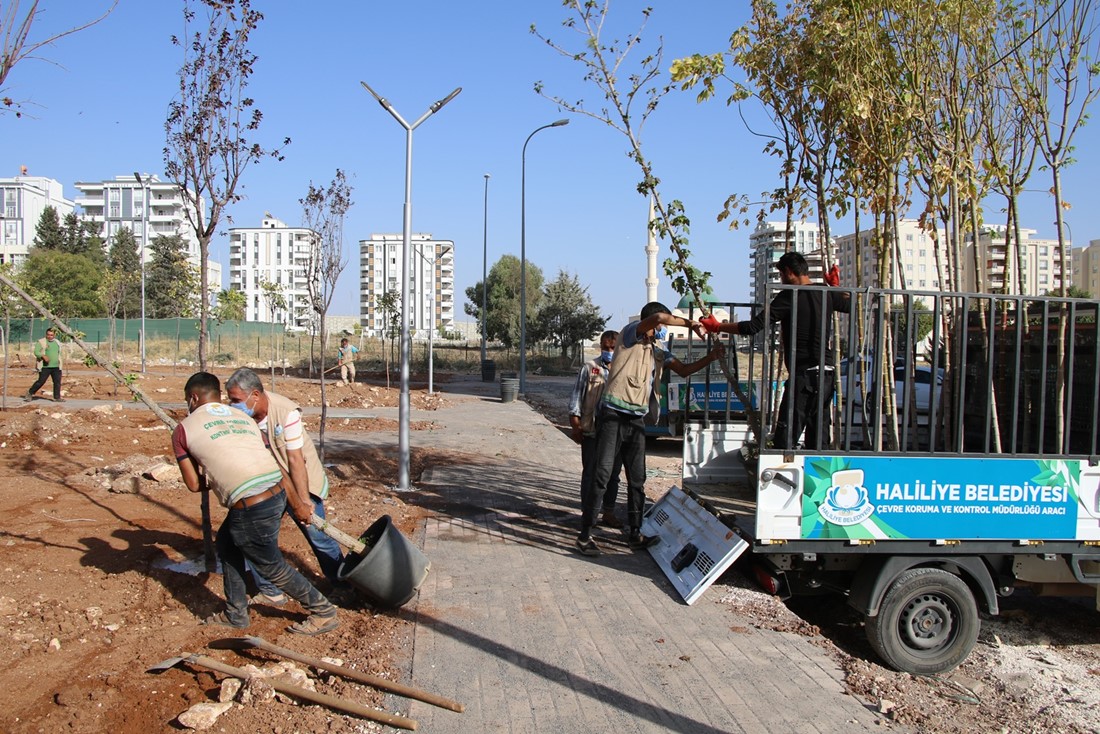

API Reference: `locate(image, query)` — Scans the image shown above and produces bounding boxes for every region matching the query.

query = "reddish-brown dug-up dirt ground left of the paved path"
[0,366,449,734]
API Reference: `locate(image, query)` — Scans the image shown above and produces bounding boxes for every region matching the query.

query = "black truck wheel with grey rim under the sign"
[867,568,981,676]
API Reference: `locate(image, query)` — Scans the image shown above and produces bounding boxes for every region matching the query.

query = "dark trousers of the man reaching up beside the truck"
[581,409,646,537]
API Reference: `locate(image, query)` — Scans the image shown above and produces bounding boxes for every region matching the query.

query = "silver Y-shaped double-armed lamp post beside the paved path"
[360,81,462,491]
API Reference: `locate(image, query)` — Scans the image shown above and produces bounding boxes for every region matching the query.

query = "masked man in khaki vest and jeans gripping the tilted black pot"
[226,368,343,606]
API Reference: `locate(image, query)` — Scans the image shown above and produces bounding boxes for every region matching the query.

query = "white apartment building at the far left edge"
[0,176,75,265]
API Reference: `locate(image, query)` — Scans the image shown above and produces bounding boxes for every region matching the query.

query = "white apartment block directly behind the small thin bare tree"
[229,212,314,329]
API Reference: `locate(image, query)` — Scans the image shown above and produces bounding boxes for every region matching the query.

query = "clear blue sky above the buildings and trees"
[8,0,1100,326]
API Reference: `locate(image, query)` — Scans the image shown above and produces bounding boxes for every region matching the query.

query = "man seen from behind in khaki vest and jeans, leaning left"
[172,372,340,635]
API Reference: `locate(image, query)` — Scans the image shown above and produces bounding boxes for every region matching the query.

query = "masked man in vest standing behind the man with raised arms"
[569,329,623,530]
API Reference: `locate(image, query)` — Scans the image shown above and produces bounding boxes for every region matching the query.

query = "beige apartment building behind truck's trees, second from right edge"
[966,224,1073,296]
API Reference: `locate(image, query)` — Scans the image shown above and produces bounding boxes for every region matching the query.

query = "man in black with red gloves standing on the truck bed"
[703,252,851,450]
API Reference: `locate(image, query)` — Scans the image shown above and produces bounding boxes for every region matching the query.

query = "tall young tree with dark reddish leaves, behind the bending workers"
[164,0,290,370]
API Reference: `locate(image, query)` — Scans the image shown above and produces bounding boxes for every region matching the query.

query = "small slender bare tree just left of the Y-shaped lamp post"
[298,168,352,461]
